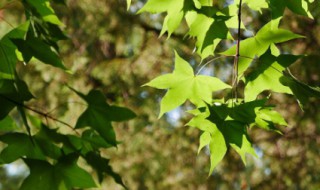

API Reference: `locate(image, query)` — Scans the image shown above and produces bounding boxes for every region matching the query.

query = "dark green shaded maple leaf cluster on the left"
[0,0,135,190]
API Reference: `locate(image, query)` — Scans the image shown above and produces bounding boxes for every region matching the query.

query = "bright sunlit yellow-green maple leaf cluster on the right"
[139,0,320,174]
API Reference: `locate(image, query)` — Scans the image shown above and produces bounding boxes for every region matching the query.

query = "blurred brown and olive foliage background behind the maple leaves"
[0,0,320,190]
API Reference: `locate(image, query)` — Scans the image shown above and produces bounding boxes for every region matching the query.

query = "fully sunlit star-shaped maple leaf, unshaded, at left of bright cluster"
[144,52,230,118]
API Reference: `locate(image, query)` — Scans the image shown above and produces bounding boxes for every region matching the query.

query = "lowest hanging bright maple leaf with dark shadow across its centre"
[187,100,287,173]
